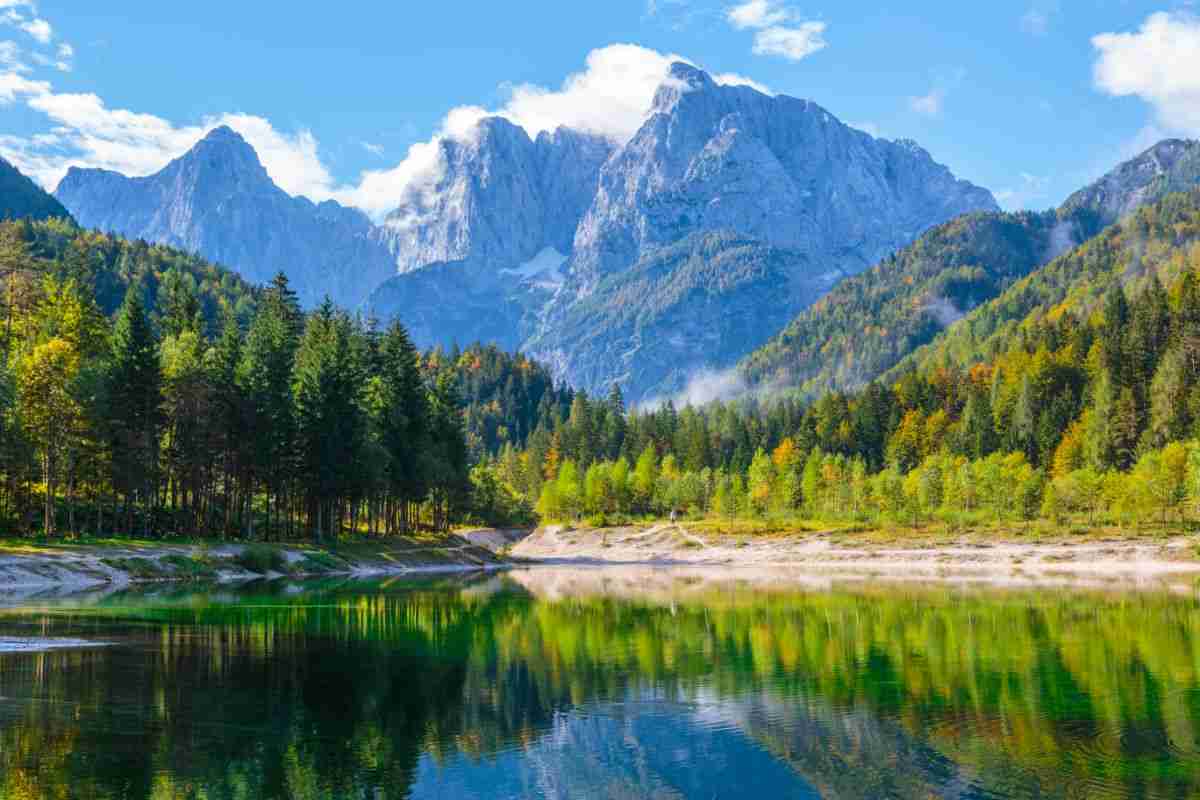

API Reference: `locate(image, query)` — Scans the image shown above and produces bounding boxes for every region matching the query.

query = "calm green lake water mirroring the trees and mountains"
[0,569,1200,800]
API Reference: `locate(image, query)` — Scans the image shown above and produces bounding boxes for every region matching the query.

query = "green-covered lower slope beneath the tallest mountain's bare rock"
[527,231,818,402]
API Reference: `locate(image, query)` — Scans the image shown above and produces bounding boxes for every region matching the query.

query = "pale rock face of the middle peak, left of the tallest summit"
[380,116,612,272]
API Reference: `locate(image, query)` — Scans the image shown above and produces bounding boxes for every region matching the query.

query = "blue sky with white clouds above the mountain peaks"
[0,0,1200,217]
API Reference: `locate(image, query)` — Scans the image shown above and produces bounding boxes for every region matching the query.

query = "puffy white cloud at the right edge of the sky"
[1092,12,1200,136]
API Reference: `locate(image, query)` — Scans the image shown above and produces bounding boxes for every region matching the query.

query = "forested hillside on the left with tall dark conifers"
[0,221,549,540]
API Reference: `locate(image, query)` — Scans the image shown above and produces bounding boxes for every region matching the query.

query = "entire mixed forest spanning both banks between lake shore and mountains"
[7,192,1200,541]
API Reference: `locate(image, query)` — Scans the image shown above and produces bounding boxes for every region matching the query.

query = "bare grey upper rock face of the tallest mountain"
[574,64,997,287]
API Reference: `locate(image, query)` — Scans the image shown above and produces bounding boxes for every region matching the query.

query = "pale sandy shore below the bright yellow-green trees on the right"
[511,524,1200,583]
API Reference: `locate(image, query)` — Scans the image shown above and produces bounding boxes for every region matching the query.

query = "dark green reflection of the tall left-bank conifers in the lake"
[0,582,499,800]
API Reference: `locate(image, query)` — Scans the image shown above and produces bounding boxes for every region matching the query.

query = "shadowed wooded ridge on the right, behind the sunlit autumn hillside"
[740,139,1200,396]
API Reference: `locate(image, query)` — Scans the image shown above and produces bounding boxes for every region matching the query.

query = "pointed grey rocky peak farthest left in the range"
[55,127,395,306]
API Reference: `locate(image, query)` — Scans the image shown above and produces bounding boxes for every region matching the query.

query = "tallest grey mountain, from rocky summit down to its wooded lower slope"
[526,64,997,402]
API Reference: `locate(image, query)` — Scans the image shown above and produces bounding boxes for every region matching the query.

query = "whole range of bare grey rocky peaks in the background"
[56,64,996,402]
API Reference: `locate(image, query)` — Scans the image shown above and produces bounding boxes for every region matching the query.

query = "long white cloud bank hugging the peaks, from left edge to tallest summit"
[0,38,767,218]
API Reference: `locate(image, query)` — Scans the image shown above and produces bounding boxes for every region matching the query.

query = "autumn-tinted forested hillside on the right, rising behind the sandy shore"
[502,191,1200,532]
